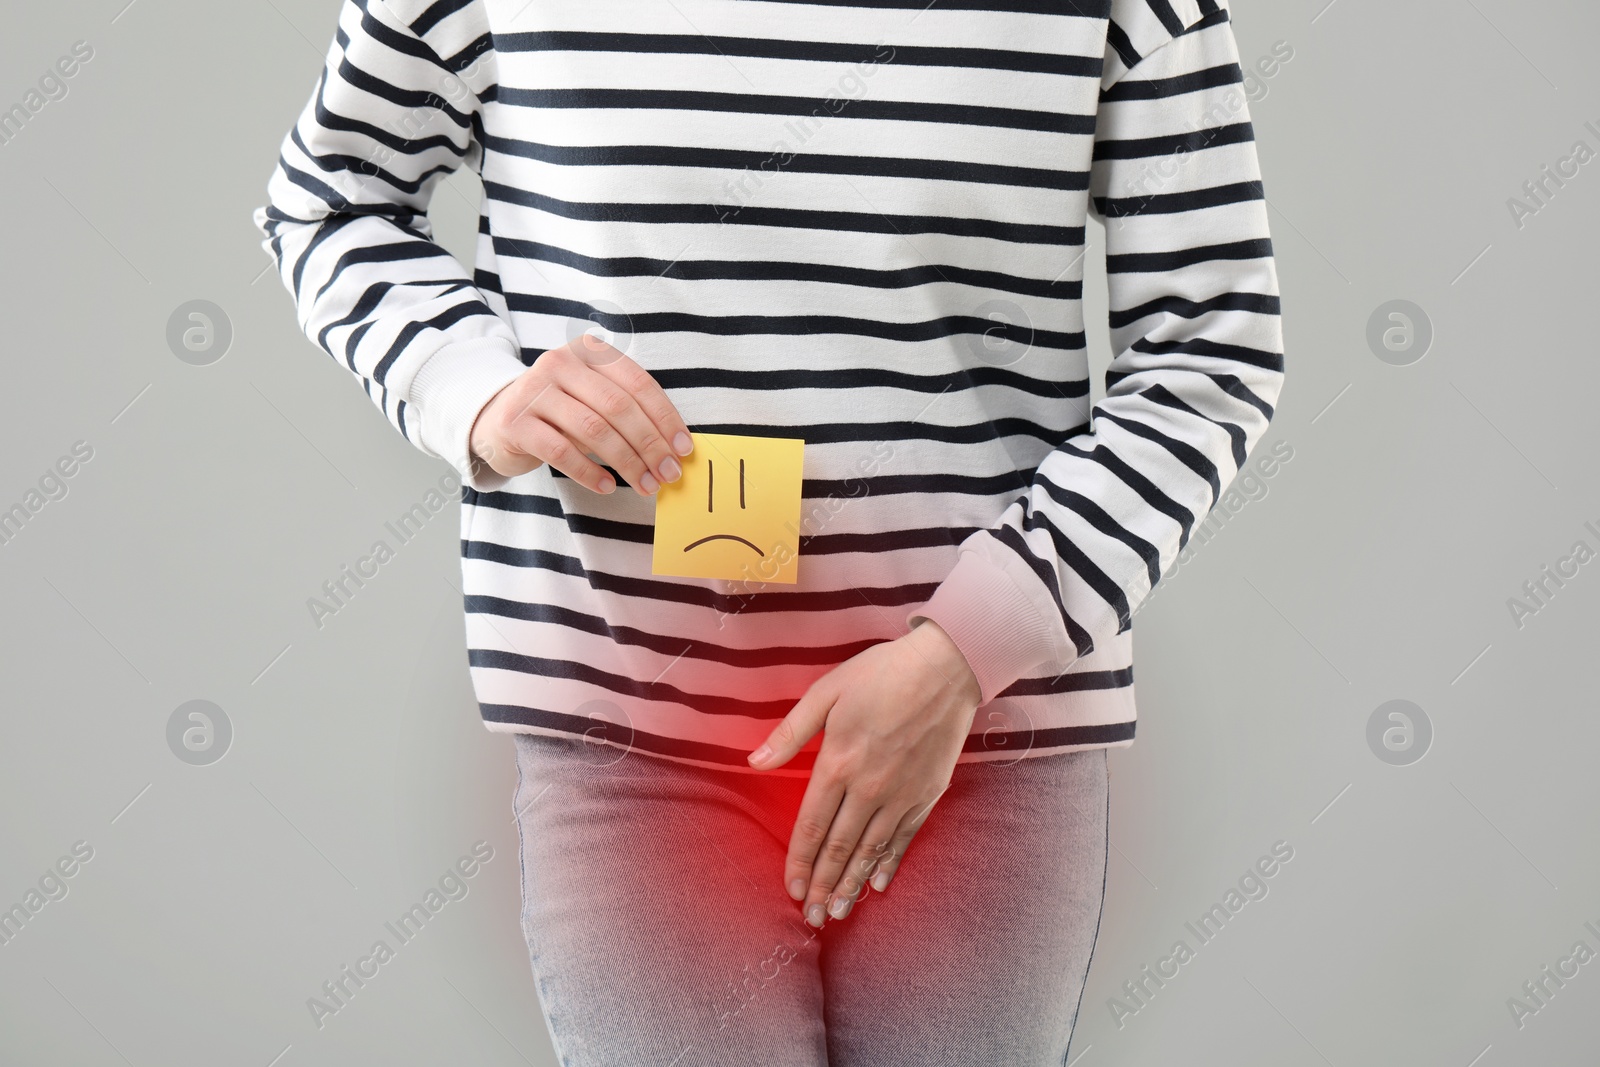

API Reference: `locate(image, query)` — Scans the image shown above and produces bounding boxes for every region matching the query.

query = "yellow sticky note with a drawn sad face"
[650,434,805,585]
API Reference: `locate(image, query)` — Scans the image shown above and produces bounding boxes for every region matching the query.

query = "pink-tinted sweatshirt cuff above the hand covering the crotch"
[906,549,1077,704]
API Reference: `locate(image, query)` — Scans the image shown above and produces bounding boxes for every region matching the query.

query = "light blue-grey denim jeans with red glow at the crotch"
[514,734,1109,1067]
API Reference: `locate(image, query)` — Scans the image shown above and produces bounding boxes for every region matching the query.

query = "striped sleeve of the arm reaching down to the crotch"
[907,0,1283,702]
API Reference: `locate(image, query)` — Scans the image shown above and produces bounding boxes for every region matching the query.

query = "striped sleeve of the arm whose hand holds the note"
[253,0,526,490]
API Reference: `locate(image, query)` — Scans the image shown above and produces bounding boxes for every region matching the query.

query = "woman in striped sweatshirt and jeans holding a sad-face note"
[254,0,1283,1067]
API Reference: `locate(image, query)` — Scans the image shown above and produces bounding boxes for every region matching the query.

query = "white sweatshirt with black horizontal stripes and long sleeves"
[253,0,1283,774]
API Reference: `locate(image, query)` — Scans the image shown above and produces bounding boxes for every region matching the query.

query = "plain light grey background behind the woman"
[0,0,1600,1067]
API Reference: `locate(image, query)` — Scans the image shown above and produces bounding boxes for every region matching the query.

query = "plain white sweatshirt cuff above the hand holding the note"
[411,338,528,493]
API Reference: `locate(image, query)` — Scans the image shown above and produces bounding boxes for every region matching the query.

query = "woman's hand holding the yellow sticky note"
[470,333,694,496]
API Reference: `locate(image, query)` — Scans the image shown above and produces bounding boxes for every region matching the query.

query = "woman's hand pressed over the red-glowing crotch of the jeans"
[749,619,981,926]
